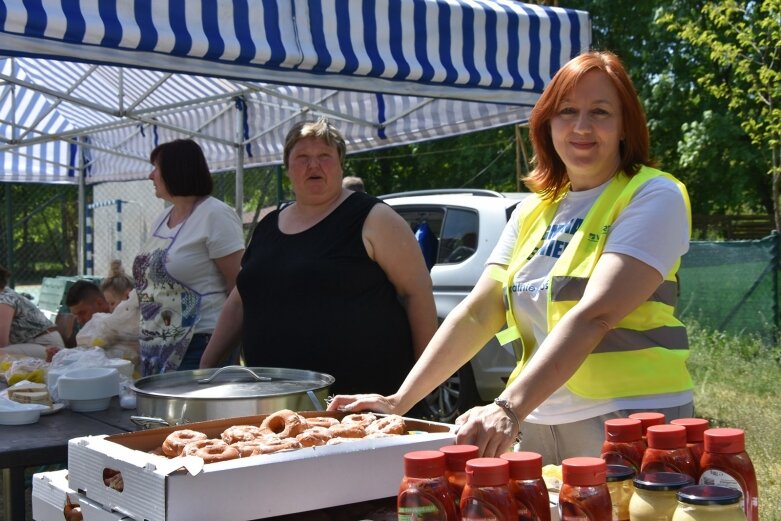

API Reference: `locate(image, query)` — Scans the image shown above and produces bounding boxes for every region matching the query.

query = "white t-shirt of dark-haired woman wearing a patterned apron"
[147,197,244,333]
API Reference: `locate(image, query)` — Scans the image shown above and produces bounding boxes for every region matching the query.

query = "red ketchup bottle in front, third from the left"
[461,458,517,521]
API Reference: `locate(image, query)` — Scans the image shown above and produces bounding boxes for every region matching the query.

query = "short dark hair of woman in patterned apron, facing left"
[149,139,214,196]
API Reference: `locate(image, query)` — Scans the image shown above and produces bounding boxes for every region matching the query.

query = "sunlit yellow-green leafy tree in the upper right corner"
[658,0,781,230]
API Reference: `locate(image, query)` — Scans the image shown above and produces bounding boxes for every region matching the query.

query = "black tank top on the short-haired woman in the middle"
[236,192,413,394]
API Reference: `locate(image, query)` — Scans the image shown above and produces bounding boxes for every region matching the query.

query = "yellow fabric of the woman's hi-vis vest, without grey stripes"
[497,167,693,399]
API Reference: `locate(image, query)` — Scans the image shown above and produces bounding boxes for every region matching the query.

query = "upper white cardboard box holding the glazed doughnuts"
[68,412,455,521]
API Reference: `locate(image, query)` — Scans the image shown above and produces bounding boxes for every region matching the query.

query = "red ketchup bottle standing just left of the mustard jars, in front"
[559,457,613,521]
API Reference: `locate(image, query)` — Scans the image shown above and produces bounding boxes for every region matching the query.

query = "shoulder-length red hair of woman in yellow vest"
[524,51,651,199]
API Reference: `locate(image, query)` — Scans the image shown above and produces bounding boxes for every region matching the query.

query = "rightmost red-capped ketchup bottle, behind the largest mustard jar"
[700,428,759,521]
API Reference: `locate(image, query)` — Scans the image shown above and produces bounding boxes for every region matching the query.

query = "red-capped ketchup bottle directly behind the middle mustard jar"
[640,425,697,479]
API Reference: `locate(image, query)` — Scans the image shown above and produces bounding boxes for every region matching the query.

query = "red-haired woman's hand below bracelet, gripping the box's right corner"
[455,404,519,458]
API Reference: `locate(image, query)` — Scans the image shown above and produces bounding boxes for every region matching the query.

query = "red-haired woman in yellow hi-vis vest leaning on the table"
[330,52,693,464]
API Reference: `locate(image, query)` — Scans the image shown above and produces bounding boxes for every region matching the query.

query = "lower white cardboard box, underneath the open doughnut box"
[32,469,130,521]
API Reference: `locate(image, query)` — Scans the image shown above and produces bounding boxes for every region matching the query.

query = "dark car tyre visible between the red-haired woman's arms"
[421,364,481,423]
